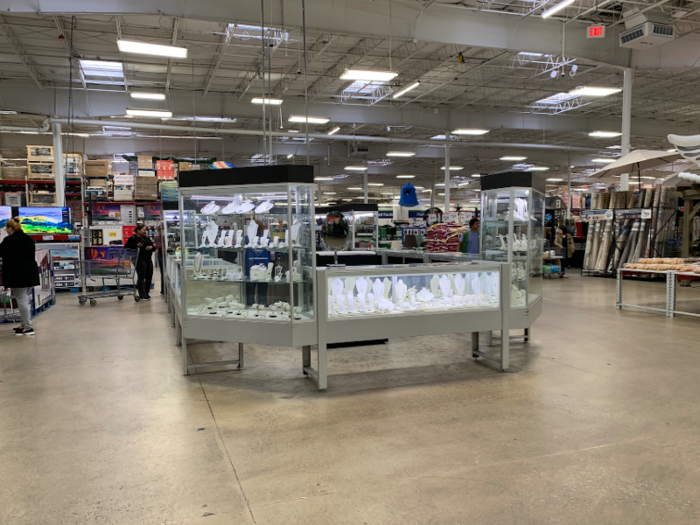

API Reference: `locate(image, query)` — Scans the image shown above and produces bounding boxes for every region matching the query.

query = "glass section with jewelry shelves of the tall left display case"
[182,180,314,322]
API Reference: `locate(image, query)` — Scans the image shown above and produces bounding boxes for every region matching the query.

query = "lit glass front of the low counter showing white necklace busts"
[327,264,500,319]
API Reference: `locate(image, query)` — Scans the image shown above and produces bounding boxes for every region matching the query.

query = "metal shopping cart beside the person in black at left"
[78,248,141,306]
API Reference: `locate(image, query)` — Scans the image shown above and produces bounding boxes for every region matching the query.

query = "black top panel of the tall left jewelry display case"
[178,166,314,188]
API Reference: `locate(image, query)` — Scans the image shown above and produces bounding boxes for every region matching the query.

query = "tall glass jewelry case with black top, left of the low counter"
[175,166,316,373]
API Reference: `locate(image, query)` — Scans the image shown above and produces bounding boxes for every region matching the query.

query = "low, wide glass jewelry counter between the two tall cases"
[303,263,510,389]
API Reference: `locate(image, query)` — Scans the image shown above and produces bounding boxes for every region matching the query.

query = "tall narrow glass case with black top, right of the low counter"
[481,172,544,307]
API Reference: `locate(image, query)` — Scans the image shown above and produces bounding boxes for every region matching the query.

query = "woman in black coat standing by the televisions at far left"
[0,217,40,335]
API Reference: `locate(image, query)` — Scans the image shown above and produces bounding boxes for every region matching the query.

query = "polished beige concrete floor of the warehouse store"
[0,276,700,525]
